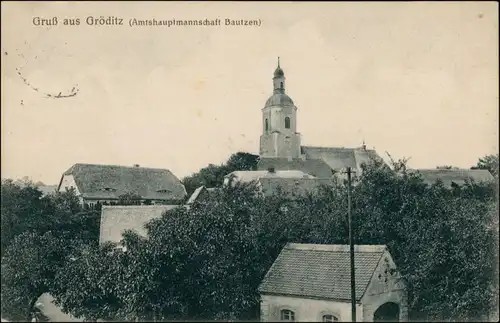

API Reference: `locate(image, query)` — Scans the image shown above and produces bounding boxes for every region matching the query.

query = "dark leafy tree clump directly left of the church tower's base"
[182,152,259,196]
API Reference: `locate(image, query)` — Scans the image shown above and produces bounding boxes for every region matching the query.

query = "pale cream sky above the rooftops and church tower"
[1,1,499,184]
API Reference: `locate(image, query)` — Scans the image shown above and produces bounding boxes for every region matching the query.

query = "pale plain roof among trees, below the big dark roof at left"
[99,205,179,243]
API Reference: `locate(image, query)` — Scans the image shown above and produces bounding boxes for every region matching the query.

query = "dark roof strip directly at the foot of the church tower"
[257,158,332,178]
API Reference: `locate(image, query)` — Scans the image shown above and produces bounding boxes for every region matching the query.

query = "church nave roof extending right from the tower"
[301,146,382,175]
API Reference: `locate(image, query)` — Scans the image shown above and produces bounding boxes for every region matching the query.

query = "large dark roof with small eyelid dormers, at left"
[58,164,187,200]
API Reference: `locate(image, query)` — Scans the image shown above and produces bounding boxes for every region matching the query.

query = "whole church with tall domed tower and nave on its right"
[258,58,382,178]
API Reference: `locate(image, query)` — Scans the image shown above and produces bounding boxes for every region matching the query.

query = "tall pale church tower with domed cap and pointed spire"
[260,57,301,159]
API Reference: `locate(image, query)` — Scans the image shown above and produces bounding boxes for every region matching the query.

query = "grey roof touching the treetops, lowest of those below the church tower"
[259,178,333,196]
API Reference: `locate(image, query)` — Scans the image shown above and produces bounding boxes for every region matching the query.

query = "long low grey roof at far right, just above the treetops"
[411,169,494,187]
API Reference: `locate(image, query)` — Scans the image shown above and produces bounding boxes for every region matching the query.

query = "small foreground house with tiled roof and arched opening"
[259,243,408,322]
